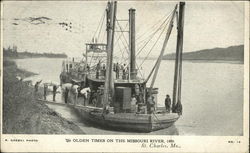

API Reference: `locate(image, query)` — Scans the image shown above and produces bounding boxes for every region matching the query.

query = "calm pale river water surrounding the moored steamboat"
[16,58,244,136]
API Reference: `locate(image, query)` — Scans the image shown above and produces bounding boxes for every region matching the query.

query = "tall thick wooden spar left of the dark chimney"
[103,2,116,110]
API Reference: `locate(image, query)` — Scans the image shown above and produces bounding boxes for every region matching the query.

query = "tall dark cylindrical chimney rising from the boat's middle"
[129,8,137,79]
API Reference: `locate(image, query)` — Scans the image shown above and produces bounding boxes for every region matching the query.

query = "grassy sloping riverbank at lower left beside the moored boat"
[3,60,85,134]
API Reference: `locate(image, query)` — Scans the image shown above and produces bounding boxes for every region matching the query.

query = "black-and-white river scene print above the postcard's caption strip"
[1,0,249,152]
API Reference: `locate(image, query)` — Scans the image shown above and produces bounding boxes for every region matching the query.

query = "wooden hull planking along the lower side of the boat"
[71,105,179,132]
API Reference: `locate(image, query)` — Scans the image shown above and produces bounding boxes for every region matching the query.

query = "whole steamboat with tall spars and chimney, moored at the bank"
[60,1,185,132]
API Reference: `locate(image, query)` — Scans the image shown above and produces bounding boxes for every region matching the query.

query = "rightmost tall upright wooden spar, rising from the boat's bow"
[172,2,185,111]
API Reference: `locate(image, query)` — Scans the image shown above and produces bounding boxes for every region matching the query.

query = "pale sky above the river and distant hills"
[2,1,244,57]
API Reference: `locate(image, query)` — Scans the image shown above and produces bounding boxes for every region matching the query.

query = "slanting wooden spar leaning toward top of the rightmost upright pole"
[150,5,177,92]
